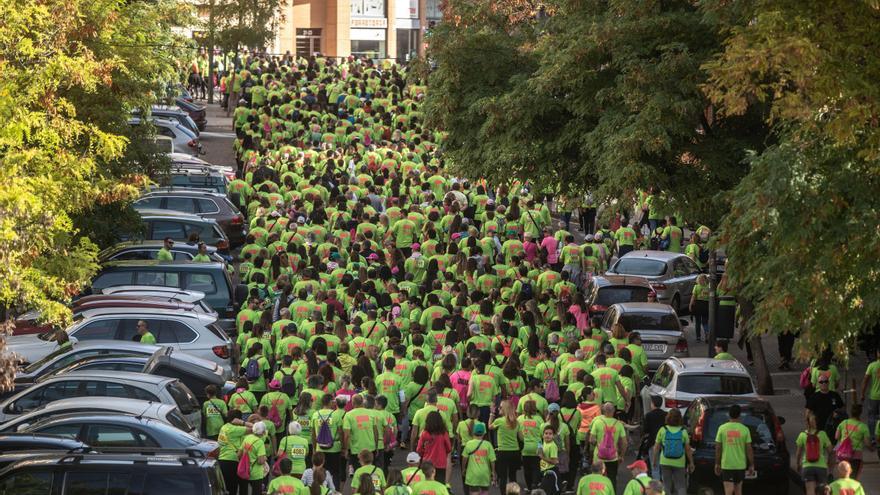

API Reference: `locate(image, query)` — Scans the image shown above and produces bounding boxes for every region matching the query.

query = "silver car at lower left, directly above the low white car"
[0,371,202,425]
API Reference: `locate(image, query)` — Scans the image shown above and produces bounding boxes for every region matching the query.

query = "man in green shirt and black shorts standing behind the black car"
[715,404,755,495]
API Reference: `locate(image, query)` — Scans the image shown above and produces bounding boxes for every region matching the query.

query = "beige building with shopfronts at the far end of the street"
[270,0,442,60]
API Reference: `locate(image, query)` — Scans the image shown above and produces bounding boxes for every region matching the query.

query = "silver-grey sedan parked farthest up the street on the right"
[606,251,700,313]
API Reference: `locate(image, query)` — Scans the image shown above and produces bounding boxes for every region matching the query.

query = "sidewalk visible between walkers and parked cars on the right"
[686,334,880,495]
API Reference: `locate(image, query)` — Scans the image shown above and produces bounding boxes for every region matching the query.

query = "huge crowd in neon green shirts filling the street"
[184,52,880,495]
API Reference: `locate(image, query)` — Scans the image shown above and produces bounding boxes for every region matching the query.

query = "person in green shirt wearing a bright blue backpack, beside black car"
[654,407,694,495]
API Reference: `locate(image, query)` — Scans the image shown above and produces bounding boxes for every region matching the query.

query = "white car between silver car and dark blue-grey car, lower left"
[0,397,199,437]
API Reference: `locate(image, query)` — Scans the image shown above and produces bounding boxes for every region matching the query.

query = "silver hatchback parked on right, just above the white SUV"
[602,303,690,371]
